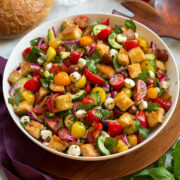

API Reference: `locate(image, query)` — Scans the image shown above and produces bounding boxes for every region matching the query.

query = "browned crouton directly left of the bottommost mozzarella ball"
[48,135,69,152]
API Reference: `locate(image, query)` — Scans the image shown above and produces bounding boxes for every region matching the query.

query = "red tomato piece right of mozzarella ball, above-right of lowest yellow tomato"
[83,109,100,125]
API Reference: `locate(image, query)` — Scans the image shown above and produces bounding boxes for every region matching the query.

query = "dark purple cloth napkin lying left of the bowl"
[0,56,62,180]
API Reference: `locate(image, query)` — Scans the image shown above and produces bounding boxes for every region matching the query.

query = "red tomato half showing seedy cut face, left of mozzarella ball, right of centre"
[109,74,124,89]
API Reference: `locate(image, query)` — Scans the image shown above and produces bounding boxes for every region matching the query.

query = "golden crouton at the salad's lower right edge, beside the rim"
[146,108,165,127]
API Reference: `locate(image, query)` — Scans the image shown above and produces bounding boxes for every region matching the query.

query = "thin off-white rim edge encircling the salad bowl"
[3,13,179,161]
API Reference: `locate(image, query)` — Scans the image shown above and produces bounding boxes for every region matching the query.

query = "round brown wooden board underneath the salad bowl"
[41,98,180,180]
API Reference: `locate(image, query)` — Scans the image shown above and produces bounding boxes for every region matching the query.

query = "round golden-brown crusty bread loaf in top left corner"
[0,0,54,39]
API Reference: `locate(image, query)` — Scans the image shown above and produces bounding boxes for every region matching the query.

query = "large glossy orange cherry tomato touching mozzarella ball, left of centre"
[54,72,71,86]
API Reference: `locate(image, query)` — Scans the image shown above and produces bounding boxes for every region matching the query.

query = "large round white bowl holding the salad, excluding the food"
[3,13,179,161]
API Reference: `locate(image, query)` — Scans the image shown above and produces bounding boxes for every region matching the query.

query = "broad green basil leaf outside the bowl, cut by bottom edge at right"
[148,167,175,180]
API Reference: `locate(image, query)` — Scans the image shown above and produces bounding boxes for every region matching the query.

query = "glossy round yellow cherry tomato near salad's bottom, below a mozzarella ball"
[71,121,86,138]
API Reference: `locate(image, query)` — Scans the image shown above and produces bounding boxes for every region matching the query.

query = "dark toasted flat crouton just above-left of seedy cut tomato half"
[97,64,116,78]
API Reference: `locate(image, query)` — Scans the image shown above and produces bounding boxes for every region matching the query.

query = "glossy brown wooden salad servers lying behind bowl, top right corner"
[113,0,180,39]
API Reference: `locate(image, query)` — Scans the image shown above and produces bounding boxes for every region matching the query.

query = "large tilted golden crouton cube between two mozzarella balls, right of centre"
[115,91,134,111]
